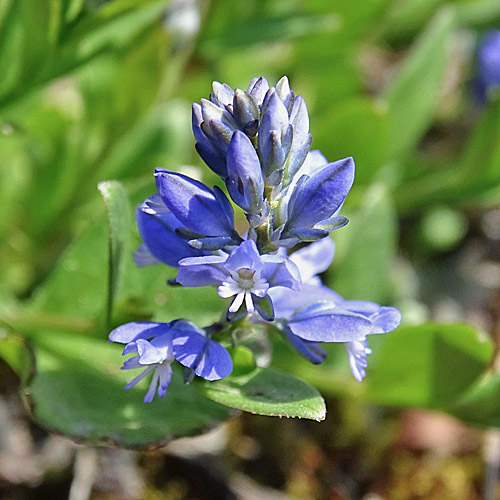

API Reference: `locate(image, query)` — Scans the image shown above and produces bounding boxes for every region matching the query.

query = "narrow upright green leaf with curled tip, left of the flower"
[98,181,132,323]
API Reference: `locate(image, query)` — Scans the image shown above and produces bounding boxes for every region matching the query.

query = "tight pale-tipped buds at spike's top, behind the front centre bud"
[193,76,312,188]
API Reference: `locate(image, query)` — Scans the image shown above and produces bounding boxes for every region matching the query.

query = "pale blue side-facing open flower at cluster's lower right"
[269,238,401,380]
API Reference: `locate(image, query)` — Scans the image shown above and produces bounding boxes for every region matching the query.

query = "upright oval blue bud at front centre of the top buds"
[226,130,264,213]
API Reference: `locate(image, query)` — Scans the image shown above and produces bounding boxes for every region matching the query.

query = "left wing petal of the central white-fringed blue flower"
[176,255,228,286]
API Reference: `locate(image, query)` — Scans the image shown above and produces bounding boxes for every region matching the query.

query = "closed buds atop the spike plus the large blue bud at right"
[192,77,354,253]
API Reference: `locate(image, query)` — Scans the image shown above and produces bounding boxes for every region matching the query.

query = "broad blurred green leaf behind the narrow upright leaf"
[25,216,227,334]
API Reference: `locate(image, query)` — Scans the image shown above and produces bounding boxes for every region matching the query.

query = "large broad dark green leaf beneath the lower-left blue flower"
[25,332,232,448]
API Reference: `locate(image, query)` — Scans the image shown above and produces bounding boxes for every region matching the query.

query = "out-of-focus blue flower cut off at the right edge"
[477,29,500,99]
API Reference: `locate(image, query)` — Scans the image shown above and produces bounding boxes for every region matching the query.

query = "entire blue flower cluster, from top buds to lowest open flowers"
[110,77,401,401]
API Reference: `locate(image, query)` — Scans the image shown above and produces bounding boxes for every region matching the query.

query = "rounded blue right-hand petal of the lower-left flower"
[172,331,233,380]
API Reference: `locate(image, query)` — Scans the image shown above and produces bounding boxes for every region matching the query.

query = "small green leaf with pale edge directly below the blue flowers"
[202,368,326,421]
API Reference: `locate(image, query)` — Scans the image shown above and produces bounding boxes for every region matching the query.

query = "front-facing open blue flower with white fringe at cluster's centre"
[177,240,301,321]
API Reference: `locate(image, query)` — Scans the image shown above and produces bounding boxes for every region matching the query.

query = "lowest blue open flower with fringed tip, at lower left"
[109,320,233,403]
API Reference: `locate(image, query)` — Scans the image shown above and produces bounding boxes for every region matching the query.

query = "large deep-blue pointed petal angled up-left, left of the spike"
[155,169,235,237]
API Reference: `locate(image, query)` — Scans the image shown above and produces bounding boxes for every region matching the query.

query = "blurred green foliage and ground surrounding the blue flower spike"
[0,0,500,500]
